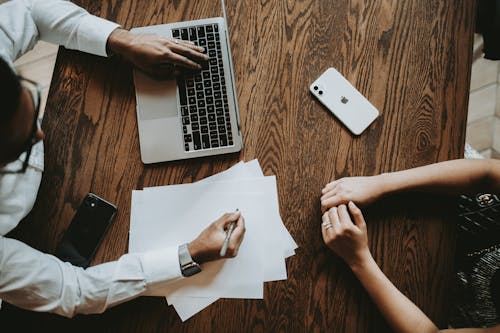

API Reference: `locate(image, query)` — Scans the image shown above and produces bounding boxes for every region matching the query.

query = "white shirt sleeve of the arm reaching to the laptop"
[0,0,119,63]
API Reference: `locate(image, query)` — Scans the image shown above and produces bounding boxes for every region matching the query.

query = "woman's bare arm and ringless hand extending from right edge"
[321,159,500,211]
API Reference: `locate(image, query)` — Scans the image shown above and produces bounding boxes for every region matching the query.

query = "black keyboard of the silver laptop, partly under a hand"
[172,24,233,151]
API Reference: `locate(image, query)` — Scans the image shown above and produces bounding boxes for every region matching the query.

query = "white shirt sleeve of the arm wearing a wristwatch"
[0,236,182,317]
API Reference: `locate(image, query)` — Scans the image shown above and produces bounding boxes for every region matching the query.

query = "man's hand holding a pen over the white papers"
[188,212,245,264]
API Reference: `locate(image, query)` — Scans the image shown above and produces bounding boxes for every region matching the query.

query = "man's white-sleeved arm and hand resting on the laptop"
[0,0,208,77]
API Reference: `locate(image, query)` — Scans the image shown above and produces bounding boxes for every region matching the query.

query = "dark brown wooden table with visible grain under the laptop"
[1,0,475,332]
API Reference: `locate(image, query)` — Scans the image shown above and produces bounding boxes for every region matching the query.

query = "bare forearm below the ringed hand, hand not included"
[351,256,438,333]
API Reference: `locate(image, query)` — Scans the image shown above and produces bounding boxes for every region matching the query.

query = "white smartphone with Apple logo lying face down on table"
[309,67,379,135]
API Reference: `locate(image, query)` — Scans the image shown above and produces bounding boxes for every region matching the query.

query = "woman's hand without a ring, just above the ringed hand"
[320,175,385,213]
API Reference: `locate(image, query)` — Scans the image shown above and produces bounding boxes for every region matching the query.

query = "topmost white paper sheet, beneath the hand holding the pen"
[129,190,269,297]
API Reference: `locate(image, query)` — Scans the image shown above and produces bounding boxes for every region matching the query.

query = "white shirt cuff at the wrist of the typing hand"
[78,15,121,57]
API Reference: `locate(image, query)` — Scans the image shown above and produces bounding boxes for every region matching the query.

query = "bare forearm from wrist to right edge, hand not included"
[380,159,500,194]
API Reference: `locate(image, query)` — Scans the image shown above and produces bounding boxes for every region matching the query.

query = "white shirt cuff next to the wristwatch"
[141,246,182,289]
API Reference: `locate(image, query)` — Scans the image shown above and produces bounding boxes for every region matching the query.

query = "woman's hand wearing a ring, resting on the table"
[321,201,371,268]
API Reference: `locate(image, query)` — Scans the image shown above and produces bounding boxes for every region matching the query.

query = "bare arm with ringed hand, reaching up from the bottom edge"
[322,202,498,333]
